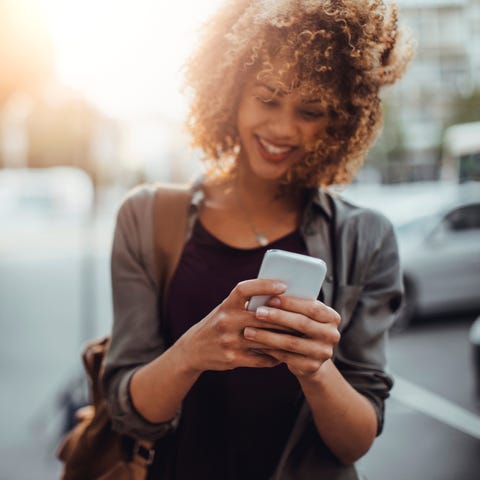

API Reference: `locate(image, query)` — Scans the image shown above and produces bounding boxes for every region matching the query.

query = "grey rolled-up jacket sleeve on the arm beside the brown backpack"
[102,186,178,440]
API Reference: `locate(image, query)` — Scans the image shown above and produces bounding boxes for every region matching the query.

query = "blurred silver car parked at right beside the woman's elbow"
[396,182,480,329]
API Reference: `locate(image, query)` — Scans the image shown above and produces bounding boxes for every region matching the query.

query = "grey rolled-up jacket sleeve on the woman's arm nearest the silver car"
[334,210,403,434]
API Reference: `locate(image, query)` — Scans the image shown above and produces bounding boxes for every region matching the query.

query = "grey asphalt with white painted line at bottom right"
[359,316,480,480]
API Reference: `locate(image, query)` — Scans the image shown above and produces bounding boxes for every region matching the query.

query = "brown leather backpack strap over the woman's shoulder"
[154,184,192,316]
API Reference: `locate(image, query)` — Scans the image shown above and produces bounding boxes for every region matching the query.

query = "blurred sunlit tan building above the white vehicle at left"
[0,85,121,186]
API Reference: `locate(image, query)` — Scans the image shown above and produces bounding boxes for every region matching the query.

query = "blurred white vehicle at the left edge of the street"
[0,167,94,260]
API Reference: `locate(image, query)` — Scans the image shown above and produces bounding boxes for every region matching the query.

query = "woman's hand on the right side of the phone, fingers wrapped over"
[244,296,340,377]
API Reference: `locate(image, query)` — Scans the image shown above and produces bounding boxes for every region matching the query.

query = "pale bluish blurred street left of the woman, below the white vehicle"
[0,196,114,480]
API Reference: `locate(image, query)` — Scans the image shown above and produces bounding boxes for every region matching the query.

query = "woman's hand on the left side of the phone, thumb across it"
[173,279,286,373]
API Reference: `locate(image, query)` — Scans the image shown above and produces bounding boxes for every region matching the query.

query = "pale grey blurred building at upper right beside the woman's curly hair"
[385,0,480,180]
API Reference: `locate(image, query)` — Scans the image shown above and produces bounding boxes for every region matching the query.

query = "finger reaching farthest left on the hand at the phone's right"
[244,327,333,361]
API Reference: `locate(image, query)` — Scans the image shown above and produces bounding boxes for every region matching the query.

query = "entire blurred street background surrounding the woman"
[0,0,480,480]
